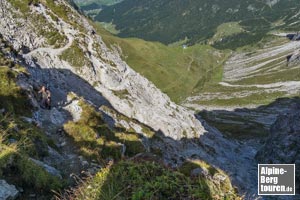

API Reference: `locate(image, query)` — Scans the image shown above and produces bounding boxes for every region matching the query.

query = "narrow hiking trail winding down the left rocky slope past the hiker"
[16,4,103,188]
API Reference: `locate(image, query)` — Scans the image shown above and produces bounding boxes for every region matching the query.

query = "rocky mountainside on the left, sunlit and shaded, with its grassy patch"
[0,0,255,198]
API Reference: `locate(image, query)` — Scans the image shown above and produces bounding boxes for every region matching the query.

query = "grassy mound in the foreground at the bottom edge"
[72,159,241,200]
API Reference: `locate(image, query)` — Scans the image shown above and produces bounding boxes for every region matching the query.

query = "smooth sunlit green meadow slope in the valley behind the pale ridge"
[95,24,228,102]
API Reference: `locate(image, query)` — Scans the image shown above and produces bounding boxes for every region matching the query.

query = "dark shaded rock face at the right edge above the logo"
[256,107,300,191]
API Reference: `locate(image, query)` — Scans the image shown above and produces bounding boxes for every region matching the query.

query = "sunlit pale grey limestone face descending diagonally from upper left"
[0,1,205,140]
